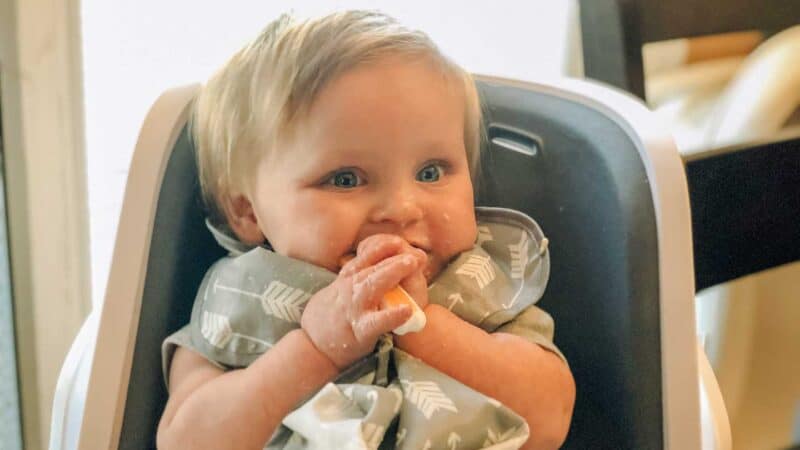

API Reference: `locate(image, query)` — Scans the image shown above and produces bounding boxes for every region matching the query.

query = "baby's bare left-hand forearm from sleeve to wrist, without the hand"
[158,329,338,450]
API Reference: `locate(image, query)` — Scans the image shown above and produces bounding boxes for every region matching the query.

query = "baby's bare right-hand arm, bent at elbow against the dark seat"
[395,304,575,449]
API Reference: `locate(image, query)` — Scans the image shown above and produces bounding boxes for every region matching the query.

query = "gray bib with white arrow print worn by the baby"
[162,208,563,450]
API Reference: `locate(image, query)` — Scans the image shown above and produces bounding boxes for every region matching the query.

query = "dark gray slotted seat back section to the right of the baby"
[479,81,663,449]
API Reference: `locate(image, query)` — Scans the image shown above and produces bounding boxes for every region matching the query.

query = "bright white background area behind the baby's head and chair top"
[81,0,577,305]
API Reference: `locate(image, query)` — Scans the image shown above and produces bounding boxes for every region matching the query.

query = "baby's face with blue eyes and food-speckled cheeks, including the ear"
[251,59,476,281]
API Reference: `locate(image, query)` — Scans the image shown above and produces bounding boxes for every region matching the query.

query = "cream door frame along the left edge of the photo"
[0,0,91,449]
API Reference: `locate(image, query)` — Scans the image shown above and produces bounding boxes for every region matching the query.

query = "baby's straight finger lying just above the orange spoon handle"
[353,253,419,311]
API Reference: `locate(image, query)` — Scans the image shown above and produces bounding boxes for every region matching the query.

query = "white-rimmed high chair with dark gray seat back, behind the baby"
[50,77,727,450]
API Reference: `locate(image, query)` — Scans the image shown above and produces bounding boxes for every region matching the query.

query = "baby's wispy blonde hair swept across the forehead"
[191,11,482,229]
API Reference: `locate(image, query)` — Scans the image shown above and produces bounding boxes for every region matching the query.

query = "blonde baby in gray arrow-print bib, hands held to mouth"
[157,11,575,449]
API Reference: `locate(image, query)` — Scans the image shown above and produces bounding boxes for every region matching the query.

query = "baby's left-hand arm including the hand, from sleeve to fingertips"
[157,249,423,450]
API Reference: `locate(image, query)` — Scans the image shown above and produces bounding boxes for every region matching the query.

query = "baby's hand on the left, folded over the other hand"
[300,235,427,369]
